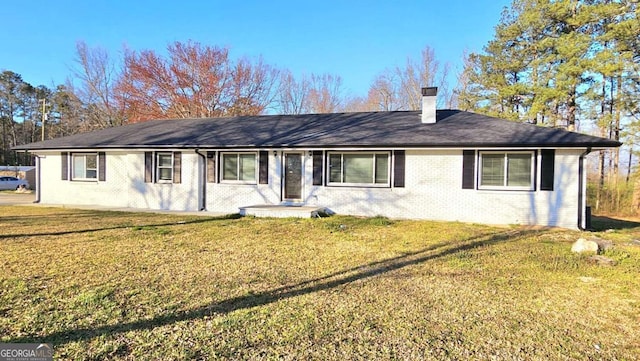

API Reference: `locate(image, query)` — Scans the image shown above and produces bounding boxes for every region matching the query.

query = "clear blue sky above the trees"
[0,0,510,95]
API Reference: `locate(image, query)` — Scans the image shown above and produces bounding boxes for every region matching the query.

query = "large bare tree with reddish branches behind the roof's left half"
[117,42,278,122]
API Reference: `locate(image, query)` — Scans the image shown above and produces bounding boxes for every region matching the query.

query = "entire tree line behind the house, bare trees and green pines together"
[5,0,640,167]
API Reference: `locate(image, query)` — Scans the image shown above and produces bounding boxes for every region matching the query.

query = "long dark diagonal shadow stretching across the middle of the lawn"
[6,229,541,344]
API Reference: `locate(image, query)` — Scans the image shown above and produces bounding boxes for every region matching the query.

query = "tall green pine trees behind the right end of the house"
[458,0,640,211]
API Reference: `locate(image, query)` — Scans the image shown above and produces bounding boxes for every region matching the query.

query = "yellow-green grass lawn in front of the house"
[0,207,640,360]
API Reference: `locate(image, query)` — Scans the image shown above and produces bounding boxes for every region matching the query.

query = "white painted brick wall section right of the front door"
[312,150,580,228]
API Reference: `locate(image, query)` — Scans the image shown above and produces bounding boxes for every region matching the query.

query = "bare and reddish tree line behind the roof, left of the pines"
[0,41,451,165]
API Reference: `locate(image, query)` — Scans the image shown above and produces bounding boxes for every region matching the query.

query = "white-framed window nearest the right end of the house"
[478,151,535,190]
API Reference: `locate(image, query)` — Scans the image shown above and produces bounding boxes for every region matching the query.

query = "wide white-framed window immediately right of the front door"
[327,152,391,187]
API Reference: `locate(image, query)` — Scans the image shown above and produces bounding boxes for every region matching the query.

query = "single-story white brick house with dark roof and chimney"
[14,88,621,228]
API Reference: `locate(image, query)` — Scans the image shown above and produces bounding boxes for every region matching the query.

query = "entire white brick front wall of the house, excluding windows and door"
[33,150,581,228]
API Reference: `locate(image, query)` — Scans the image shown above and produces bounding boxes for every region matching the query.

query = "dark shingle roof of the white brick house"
[14,110,621,150]
